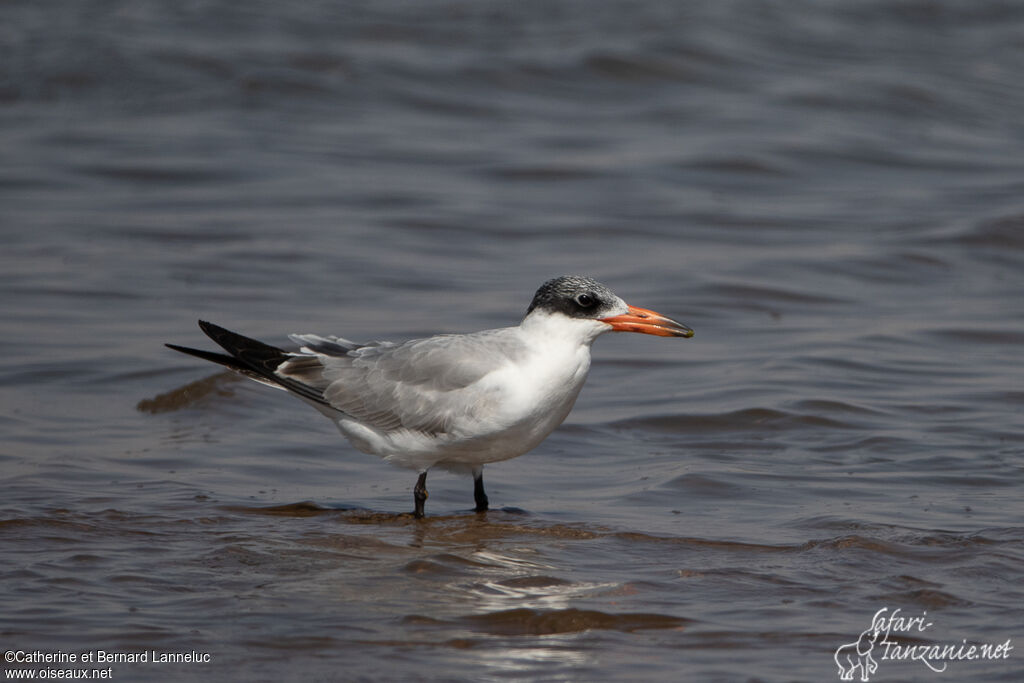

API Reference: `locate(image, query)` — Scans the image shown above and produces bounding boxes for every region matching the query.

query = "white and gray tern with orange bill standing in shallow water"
[166,275,693,519]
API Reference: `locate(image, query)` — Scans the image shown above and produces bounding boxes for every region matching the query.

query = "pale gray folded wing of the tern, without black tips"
[275,328,524,434]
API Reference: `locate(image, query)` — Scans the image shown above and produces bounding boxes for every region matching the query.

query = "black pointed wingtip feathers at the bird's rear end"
[166,321,329,405]
